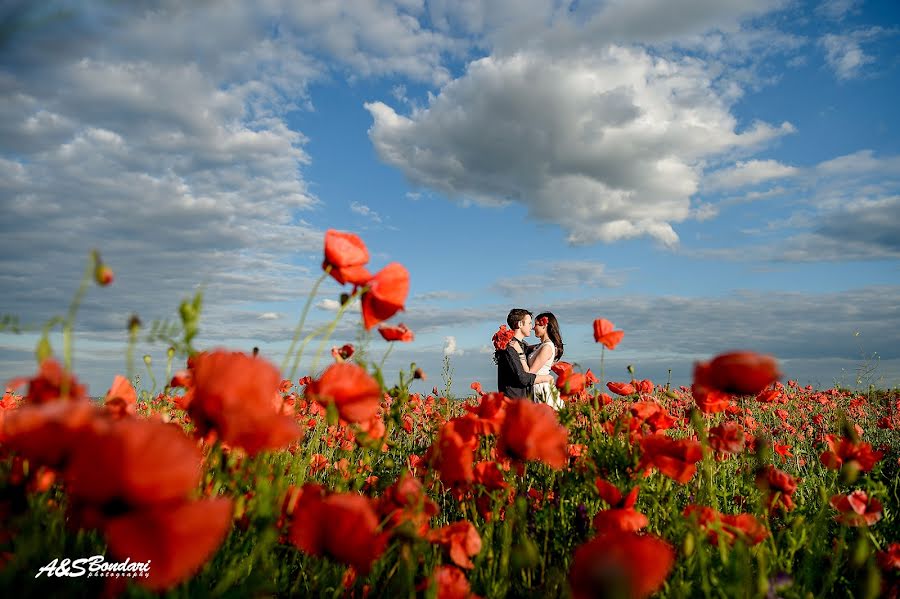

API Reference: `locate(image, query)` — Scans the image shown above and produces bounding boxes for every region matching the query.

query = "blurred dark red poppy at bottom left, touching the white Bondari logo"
[104,498,232,591]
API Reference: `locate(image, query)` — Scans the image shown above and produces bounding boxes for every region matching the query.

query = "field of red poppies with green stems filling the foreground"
[0,231,900,598]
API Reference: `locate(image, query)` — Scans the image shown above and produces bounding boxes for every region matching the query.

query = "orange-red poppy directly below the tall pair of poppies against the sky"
[306,364,382,422]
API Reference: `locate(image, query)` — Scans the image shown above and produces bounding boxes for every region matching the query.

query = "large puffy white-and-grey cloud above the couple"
[366,46,793,245]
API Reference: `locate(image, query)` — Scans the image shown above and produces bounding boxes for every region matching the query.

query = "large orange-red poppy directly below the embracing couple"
[497,399,569,469]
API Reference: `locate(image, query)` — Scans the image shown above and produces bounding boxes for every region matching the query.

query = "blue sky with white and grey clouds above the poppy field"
[0,0,900,396]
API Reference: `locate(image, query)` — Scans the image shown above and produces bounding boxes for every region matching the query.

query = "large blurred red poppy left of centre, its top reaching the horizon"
[187,350,300,455]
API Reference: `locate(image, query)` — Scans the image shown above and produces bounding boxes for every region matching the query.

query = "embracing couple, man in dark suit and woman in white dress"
[495,308,563,410]
